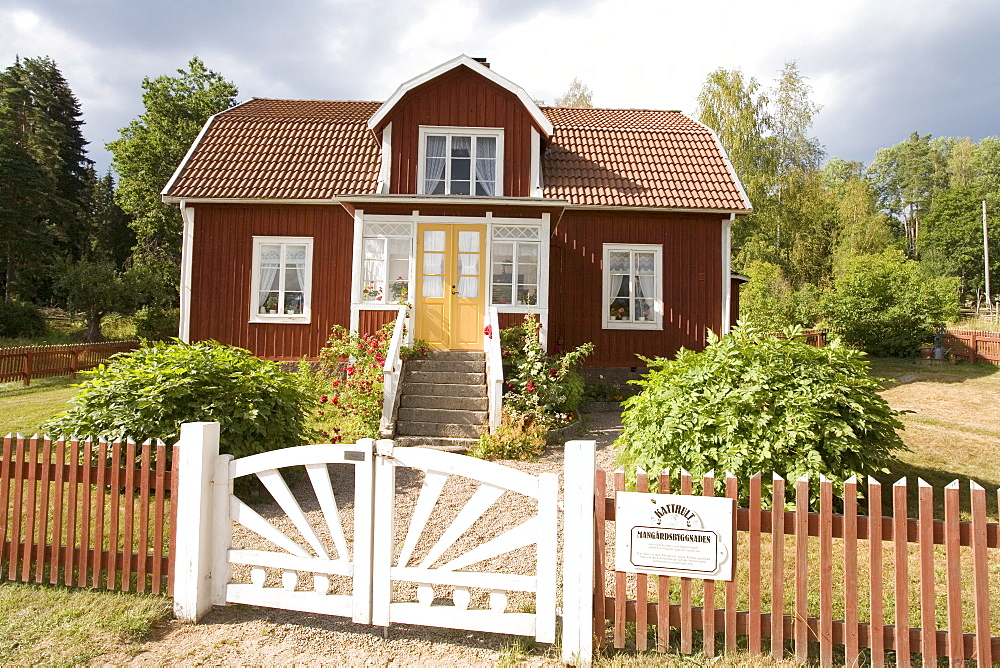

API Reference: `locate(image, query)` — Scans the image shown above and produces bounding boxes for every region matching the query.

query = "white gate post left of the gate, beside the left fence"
[171,422,219,622]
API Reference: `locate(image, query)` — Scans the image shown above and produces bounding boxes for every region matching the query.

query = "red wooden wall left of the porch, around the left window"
[190,204,354,359]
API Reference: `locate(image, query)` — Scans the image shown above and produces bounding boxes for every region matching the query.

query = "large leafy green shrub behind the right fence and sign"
[617,325,905,506]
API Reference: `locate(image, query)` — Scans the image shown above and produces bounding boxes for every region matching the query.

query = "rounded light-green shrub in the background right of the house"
[823,250,958,357]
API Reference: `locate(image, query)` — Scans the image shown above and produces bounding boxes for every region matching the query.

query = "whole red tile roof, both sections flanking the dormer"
[160,99,747,211]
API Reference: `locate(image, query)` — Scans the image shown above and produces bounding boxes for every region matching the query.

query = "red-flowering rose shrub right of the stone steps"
[500,315,594,428]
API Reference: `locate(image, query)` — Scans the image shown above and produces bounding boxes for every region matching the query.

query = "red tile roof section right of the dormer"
[543,108,747,211]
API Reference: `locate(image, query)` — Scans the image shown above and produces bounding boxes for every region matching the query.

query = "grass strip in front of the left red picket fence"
[0,582,170,665]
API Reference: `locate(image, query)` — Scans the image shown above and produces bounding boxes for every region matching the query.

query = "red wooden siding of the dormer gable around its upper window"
[378,67,534,197]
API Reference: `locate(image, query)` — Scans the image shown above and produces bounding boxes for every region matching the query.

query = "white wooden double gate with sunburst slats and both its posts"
[174,423,593,660]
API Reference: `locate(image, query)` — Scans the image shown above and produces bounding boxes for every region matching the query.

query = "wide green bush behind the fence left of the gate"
[45,341,314,457]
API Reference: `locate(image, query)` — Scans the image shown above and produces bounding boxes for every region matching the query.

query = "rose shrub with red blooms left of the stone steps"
[311,323,394,443]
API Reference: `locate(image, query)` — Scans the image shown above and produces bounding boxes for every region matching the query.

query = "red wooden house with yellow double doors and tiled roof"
[163,56,750,367]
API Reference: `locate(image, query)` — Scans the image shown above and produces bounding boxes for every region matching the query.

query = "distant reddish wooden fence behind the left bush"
[0,341,140,386]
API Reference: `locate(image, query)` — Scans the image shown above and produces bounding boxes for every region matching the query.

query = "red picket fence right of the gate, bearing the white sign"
[594,469,1000,666]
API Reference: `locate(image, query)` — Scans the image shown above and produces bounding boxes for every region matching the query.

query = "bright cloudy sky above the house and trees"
[0,0,1000,174]
